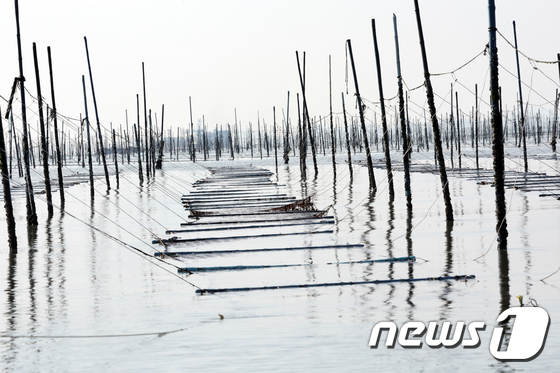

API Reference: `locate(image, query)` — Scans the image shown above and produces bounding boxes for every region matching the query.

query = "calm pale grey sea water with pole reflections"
[0,150,560,372]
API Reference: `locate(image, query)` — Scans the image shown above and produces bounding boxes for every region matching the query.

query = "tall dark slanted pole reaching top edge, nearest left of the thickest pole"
[414,0,453,221]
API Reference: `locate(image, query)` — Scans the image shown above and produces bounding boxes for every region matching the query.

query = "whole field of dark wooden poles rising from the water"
[0,0,560,250]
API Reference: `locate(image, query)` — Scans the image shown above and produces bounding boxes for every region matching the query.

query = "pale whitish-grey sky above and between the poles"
[0,0,560,132]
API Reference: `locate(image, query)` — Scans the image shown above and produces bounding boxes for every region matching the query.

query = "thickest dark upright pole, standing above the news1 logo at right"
[488,0,508,250]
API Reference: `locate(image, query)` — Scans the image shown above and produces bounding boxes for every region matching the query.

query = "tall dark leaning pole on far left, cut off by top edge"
[15,0,38,225]
